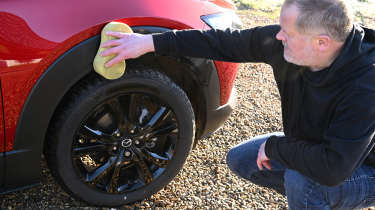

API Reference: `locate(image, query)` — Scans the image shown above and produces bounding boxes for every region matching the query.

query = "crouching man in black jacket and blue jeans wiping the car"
[102,0,375,209]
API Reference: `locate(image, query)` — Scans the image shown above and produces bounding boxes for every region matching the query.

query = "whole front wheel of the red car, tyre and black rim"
[45,70,195,206]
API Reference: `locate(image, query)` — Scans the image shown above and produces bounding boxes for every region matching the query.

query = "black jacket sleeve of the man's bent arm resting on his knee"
[265,83,375,186]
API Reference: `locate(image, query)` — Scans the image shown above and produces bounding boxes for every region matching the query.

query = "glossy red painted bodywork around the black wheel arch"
[0,0,233,151]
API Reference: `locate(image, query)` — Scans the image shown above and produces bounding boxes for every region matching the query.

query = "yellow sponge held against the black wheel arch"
[93,22,133,79]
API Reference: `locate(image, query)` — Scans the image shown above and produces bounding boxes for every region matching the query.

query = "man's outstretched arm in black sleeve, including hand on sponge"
[101,25,282,67]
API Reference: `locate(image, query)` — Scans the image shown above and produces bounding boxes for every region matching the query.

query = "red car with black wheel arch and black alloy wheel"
[0,0,240,206]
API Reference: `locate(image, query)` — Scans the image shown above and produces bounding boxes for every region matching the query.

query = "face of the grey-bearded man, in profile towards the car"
[276,5,314,66]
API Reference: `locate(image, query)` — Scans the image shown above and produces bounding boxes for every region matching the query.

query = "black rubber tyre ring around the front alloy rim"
[56,74,195,206]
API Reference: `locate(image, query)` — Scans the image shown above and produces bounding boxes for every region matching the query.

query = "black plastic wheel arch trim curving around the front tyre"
[6,26,214,189]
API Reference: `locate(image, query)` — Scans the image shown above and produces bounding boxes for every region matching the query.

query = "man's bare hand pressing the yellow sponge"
[100,31,155,68]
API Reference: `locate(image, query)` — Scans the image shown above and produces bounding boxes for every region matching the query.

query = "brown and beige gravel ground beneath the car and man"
[0,12,374,209]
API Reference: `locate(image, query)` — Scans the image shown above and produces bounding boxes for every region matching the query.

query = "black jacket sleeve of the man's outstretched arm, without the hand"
[153,25,282,63]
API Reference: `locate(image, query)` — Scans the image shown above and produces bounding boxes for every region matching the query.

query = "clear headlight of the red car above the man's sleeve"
[201,12,242,30]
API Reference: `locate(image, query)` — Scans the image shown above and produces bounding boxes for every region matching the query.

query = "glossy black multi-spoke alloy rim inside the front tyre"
[72,93,178,193]
